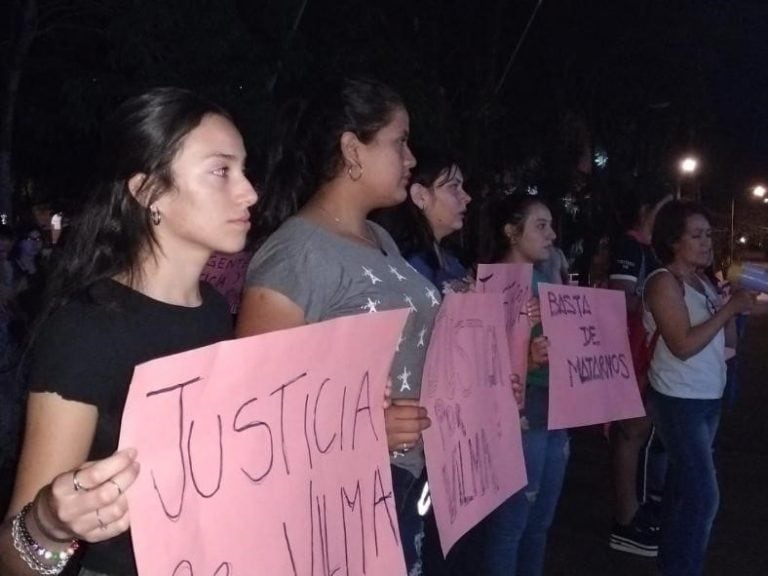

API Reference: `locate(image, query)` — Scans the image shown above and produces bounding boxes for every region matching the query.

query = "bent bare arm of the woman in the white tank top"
[646,274,752,360]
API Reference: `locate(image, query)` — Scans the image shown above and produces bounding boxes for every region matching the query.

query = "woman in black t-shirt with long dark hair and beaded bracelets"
[0,88,256,576]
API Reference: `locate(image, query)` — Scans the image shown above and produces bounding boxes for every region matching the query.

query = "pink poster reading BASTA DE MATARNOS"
[539,284,645,430]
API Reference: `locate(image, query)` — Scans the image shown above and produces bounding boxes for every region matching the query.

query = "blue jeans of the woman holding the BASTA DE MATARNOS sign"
[484,388,570,576]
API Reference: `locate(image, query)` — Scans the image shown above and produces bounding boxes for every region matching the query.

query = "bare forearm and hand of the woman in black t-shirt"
[0,393,138,576]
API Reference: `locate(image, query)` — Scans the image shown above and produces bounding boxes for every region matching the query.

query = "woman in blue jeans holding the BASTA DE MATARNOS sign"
[482,195,569,576]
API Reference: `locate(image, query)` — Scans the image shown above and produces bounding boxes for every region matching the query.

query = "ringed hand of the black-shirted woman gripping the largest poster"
[32,449,139,542]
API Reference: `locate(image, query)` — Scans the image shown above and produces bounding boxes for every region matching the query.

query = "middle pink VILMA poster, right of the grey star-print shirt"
[421,293,527,554]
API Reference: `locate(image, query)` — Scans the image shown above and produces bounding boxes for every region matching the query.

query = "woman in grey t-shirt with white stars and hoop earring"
[237,78,440,573]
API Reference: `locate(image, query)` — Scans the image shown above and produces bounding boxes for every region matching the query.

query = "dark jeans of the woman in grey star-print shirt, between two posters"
[390,466,426,576]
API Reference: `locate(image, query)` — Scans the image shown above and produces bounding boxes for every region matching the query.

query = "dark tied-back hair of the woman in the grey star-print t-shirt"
[256,78,404,236]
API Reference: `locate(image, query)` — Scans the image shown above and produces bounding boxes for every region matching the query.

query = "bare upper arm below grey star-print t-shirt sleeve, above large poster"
[235,286,306,338]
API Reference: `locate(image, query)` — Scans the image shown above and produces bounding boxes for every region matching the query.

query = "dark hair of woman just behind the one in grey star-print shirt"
[374,149,460,260]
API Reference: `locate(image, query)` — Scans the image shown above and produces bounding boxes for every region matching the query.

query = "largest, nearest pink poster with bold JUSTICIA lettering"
[120,310,407,576]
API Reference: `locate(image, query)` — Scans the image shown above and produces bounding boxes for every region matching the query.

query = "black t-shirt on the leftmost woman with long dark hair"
[30,280,233,576]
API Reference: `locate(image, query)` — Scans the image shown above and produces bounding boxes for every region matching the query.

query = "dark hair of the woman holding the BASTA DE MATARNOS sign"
[478,194,546,263]
